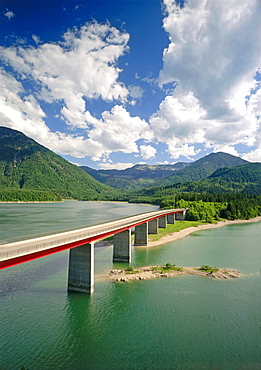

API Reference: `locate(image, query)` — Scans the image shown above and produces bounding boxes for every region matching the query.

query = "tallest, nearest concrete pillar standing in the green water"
[68,243,94,294]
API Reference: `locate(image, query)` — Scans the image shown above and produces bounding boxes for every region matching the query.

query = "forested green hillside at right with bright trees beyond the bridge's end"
[121,163,261,222]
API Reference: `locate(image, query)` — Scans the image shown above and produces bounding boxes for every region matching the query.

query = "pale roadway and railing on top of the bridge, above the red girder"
[0,208,186,261]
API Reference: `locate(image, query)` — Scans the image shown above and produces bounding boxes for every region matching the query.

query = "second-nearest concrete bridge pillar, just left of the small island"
[113,229,131,263]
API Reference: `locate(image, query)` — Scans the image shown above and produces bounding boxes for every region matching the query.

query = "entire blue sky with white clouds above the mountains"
[0,0,261,169]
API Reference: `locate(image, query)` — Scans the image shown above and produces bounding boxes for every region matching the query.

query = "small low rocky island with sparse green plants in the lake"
[109,263,240,282]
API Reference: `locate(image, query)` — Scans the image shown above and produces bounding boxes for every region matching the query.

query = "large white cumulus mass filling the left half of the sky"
[0,22,152,160]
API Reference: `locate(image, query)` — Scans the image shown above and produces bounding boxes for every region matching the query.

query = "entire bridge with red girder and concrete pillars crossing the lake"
[0,208,187,293]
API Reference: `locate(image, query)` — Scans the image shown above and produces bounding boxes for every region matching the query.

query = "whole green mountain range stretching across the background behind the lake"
[0,127,261,200]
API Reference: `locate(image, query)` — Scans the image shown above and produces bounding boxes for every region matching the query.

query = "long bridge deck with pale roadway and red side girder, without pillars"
[0,208,186,269]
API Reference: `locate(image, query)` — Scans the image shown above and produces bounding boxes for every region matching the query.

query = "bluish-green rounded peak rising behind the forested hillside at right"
[154,152,249,186]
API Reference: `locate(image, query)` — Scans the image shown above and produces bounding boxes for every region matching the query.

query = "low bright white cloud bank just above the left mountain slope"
[0,63,152,161]
